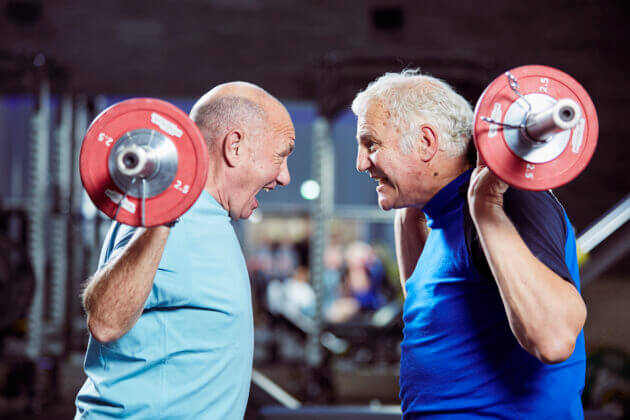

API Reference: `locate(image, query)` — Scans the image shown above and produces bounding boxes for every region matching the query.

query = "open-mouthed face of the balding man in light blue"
[229,104,295,219]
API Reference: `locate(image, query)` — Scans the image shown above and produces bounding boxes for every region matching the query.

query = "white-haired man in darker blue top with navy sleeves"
[352,70,586,419]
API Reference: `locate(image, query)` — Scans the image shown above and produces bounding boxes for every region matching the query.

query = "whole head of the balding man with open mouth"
[190,82,295,219]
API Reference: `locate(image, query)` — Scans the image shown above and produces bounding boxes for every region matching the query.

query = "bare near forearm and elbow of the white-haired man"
[471,205,586,363]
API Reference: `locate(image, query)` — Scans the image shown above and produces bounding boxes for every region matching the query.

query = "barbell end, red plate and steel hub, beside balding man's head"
[79,98,208,226]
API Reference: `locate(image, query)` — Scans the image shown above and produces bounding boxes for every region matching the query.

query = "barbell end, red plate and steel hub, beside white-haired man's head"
[473,65,599,191]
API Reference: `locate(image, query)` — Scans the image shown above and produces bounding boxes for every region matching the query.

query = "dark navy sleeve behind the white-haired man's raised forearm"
[464,187,575,284]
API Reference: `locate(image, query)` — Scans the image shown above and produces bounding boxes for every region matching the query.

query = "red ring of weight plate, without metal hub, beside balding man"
[79,98,208,226]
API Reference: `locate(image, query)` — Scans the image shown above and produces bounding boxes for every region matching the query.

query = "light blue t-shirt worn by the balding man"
[75,191,254,420]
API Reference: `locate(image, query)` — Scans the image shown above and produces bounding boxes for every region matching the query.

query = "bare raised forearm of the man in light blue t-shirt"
[83,226,170,342]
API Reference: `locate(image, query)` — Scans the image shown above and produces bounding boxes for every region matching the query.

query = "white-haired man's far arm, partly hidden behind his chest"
[394,207,429,297]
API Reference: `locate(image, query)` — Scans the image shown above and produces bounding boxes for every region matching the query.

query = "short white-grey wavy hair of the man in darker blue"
[352,69,473,157]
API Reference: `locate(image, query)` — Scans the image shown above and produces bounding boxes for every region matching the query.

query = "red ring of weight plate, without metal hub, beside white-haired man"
[474,65,599,191]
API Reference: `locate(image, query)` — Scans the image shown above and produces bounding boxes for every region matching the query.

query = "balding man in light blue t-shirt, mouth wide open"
[75,82,295,420]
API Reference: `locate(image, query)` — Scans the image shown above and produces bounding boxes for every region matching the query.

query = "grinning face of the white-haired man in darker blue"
[356,99,432,210]
